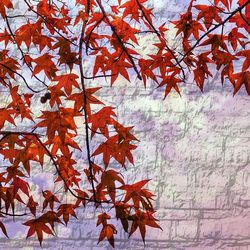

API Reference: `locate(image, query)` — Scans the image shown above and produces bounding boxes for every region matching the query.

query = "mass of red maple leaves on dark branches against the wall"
[0,0,250,247]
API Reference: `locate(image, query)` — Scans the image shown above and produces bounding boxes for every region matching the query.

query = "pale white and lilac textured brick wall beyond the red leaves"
[0,0,250,250]
